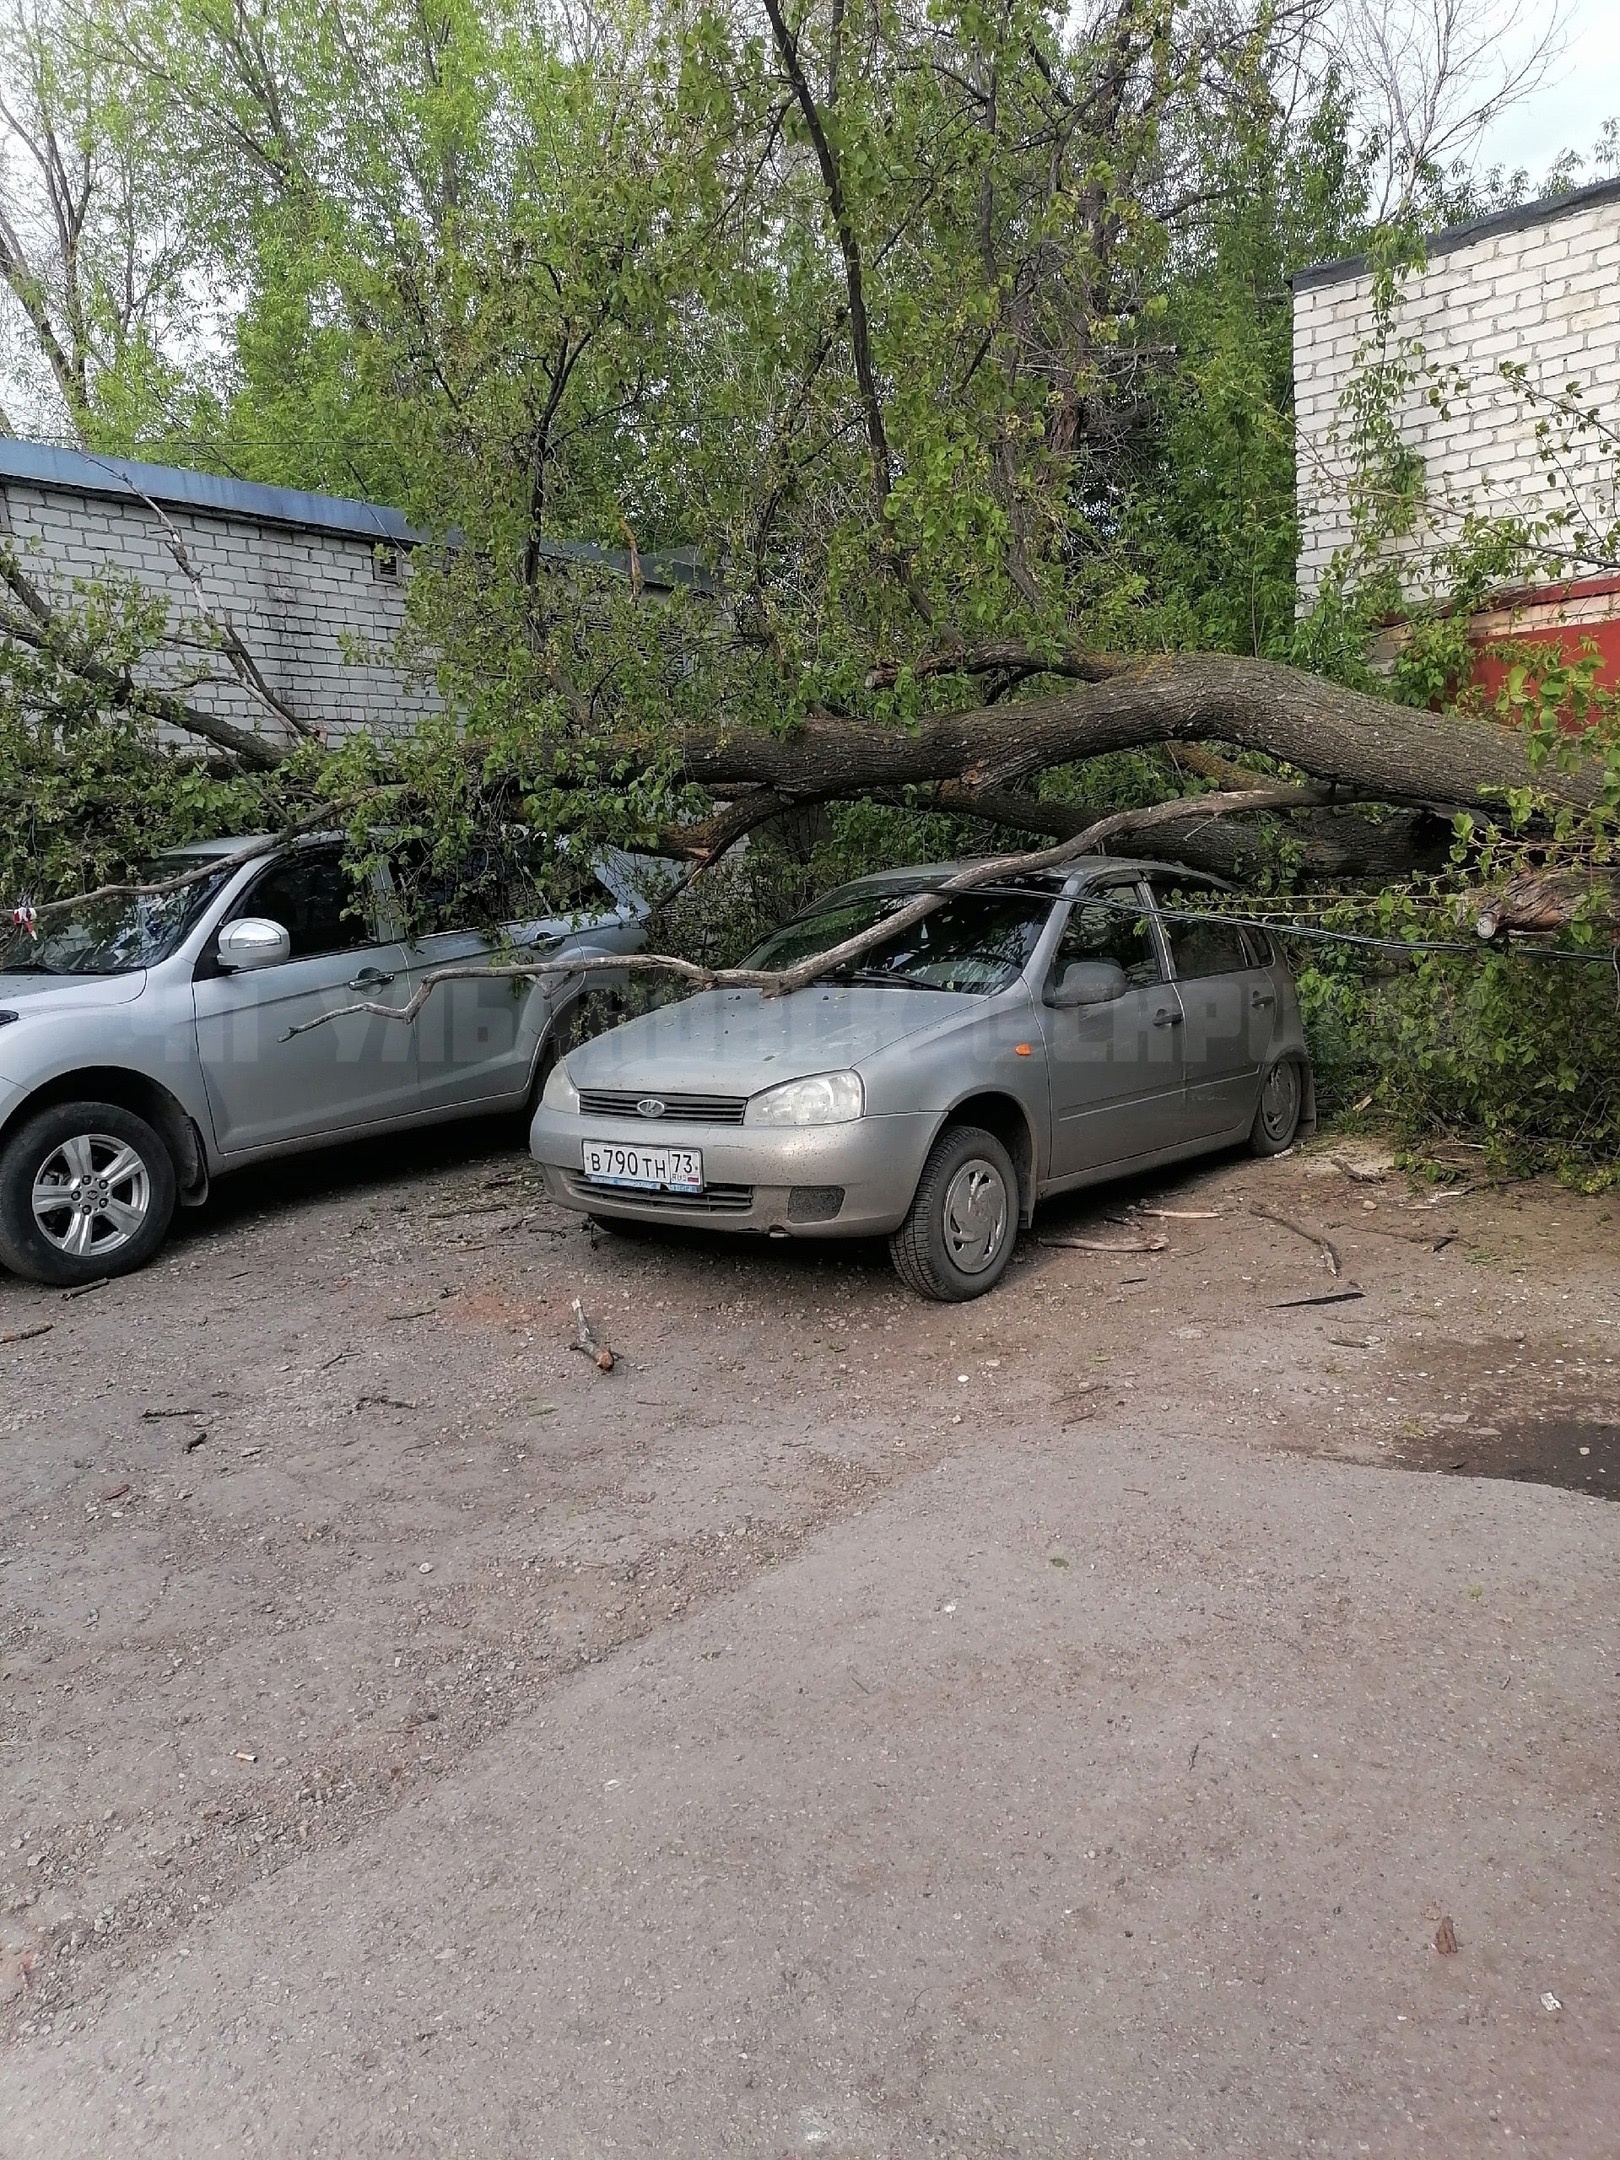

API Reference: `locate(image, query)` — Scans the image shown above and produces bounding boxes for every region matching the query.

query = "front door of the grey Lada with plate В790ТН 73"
[1041,883,1184,1179]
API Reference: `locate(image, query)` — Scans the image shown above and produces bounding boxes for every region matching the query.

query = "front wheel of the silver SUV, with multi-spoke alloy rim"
[0,1102,175,1290]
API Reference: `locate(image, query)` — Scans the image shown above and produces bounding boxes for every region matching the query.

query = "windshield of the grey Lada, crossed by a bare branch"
[745,888,1052,998]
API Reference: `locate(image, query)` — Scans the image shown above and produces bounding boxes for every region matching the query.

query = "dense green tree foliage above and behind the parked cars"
[0,0,1620,1183]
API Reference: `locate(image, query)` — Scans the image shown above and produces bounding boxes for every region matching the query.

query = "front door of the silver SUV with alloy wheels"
[192,847,419,1156]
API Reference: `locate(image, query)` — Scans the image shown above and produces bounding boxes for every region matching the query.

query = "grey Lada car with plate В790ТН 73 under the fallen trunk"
[529,858,1315,1298]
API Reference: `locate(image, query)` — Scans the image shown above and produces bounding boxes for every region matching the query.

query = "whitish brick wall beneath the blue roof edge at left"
[4,480,436,741]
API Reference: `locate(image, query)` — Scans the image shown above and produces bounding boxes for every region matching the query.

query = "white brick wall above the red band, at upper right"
[1294,192,1620,609]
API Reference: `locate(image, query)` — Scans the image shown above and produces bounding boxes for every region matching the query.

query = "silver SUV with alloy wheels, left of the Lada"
[0,840,648,1285]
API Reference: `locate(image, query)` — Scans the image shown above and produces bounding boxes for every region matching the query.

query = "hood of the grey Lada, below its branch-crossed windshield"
[568,983,985,1095]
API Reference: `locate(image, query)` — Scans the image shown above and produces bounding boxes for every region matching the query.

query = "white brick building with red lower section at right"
[1292,181,1620,687]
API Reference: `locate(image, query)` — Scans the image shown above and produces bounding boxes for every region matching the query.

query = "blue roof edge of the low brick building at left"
[0,436,717,594]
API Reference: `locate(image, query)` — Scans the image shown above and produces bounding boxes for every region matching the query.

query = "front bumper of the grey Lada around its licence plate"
[529,1108,940,1238]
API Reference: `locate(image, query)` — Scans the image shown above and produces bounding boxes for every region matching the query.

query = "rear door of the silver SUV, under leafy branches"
[410,859,642,1110]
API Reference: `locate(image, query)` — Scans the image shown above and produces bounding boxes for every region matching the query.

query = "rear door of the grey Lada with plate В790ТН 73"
[1153,879,1277,1140]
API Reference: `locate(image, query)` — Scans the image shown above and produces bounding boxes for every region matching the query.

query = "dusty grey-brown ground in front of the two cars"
[0,1130,1620,2160]
